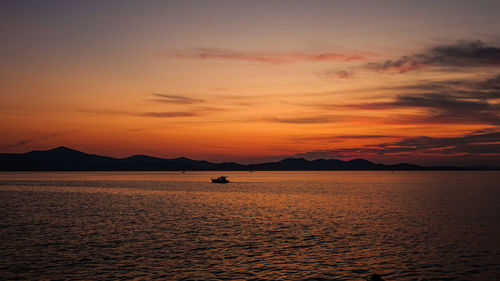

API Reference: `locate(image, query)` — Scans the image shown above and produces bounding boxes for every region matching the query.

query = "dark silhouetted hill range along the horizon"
[0,146,499,171]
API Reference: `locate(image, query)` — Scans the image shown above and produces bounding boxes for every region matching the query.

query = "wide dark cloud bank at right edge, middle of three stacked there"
[336,75,500,125]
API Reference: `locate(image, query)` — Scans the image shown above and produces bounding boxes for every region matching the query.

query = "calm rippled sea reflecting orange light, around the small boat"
[0,172,500,280]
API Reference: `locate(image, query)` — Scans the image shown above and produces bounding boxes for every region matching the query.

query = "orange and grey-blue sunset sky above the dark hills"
[0,0,500,165]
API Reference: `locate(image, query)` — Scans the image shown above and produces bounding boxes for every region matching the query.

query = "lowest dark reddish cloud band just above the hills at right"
[294,131,500,159]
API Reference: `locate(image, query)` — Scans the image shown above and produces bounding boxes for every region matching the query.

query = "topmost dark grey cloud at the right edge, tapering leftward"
[364,40,500,73]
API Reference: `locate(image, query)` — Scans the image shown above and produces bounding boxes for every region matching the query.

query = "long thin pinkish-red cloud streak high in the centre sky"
[169,48,373,64]
